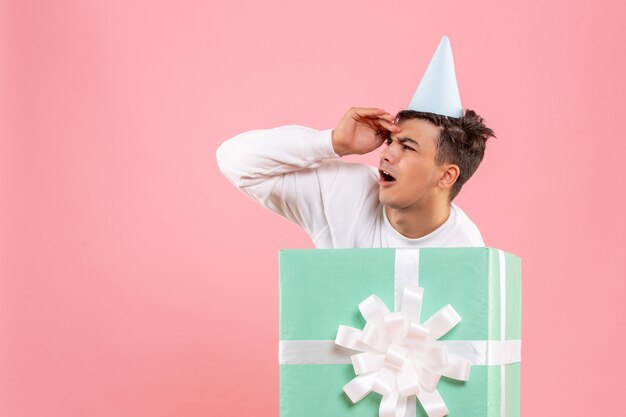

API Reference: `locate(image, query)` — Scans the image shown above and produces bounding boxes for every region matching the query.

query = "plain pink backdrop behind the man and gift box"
[0,0,626,417]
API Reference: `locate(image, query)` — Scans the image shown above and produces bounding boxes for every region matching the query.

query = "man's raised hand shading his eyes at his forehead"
[332,107,401,156]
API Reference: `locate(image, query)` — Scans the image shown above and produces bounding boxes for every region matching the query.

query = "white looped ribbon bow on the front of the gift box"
[335,283,471,417]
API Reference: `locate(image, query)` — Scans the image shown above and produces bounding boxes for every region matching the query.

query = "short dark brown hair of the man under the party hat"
[396,109,496,201]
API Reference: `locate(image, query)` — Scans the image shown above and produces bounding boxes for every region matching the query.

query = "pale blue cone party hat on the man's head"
[408,35,463,117]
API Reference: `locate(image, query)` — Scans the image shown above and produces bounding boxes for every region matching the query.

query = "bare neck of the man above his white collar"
[384,201,450,239]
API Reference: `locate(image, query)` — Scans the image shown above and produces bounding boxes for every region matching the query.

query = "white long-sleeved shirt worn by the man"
[217,125,484,249]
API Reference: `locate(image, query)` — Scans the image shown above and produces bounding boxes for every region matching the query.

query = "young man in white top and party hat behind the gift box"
[217,37,493,248]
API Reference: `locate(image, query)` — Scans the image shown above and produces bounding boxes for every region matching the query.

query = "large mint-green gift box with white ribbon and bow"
[279,247,521,417]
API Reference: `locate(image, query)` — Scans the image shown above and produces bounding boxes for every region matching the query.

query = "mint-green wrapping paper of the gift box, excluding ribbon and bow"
[279,248,521,417]
